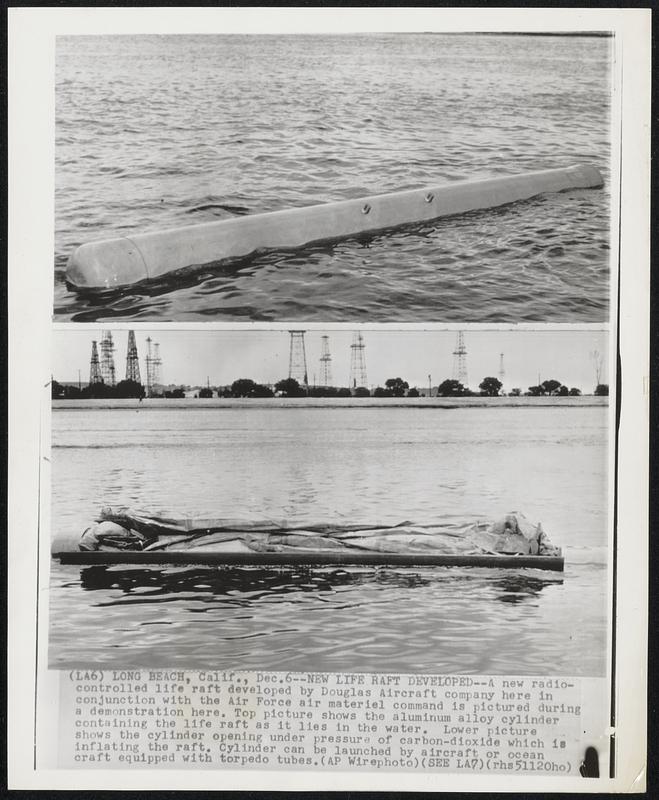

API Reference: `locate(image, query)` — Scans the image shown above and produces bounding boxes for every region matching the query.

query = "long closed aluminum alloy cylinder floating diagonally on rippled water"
[66,164,603,289]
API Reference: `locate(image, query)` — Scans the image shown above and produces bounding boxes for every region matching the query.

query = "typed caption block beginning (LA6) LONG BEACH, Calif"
[58,669,583,776]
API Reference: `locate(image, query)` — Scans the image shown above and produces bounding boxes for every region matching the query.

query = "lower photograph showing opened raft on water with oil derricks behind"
[48,325,611,677]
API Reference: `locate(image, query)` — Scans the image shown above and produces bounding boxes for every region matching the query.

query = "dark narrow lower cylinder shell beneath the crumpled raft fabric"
[53,550,564,572]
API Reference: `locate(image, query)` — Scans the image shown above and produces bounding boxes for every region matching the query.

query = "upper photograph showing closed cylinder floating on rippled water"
[54,31,617,323]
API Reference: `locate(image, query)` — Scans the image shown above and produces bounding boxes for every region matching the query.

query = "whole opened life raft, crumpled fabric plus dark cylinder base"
[54,508,563,570]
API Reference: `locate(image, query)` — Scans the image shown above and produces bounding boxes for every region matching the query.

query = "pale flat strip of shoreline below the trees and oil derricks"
[52,395,609,411]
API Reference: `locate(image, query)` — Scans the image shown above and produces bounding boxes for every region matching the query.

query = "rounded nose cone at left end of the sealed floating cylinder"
[66,239,149,289]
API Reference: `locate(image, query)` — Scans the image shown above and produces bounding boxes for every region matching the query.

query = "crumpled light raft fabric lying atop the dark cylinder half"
[78,508,561,556]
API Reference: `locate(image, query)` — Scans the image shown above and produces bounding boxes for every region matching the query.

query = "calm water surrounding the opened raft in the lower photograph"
[49,407,607,676]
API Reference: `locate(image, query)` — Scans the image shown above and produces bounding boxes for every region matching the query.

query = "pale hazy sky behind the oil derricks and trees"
[53,327,608,393]
